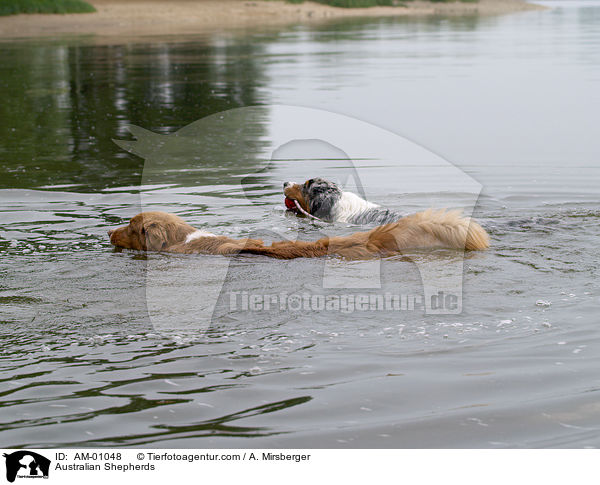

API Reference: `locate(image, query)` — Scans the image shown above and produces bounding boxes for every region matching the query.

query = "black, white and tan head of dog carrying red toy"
[283,178,342,221]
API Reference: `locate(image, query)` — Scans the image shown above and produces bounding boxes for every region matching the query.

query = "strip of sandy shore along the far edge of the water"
[0,0,543,39]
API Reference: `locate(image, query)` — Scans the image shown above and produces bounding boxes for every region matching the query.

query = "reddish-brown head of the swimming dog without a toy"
[108,212,195,251]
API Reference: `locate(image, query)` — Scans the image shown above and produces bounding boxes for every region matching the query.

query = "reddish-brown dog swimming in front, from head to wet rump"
[108,209,489,260]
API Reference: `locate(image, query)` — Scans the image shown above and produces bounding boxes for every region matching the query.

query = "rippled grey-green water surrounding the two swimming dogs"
[0,2,600,448]
